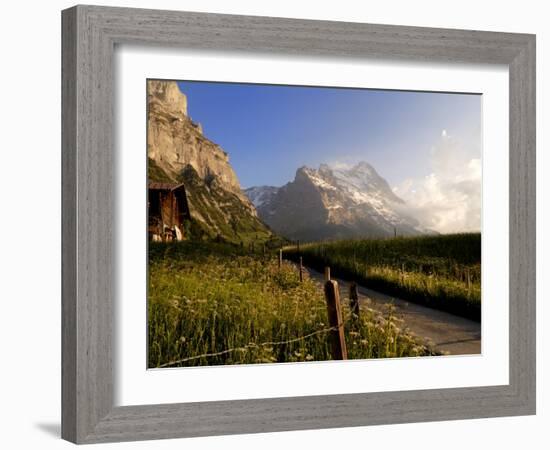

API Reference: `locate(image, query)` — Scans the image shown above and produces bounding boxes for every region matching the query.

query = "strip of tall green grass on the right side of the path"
[285,233,481,320]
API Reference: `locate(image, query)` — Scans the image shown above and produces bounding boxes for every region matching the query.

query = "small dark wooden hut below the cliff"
[147,181,190,242]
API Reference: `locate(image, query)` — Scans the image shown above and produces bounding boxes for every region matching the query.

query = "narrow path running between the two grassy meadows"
[306,267,481,355]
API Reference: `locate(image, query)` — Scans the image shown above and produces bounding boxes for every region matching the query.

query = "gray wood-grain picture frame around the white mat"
[62,6,536,443]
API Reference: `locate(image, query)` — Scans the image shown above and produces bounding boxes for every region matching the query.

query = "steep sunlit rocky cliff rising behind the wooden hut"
[147,80,271,242]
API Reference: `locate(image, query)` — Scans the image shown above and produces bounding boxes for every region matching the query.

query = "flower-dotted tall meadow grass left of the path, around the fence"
[148,242,440,367]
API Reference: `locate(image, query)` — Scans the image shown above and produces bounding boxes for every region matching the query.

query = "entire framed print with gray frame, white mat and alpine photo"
[62,6,535,443]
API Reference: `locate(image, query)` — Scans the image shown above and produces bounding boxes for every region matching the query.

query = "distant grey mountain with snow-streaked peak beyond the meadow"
[246,162,423,240]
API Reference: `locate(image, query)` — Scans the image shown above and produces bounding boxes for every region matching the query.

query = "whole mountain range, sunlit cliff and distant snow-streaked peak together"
[147,80,427,242]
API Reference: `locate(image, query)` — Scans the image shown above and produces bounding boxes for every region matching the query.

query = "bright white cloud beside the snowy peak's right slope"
[394,130,481,233]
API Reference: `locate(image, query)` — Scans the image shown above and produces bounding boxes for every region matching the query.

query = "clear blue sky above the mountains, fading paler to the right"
[178,81,481,188]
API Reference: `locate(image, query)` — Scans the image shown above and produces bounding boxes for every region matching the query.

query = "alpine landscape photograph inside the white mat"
[144,79,483,369]
